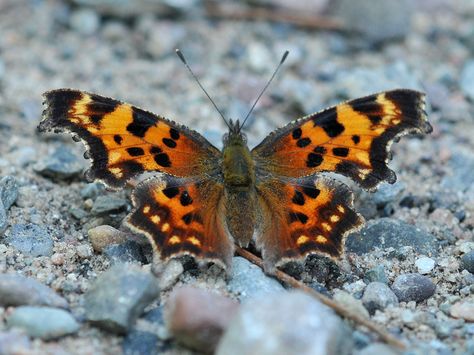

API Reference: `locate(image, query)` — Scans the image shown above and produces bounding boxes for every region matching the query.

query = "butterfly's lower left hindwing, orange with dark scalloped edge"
[127,176,233,268]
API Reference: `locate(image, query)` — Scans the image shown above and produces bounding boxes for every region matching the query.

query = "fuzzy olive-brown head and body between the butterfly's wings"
[222,121,257,246]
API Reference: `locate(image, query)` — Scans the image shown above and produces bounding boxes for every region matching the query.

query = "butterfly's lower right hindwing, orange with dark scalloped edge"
[256,178,363,270]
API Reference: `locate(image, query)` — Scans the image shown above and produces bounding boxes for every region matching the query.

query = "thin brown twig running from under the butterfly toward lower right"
[236,246,406,350]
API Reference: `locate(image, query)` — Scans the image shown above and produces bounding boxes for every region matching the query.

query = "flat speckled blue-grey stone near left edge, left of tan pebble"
[5,223,53,257]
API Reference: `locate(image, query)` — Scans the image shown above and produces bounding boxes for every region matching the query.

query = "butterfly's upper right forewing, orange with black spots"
[252,90,431,189]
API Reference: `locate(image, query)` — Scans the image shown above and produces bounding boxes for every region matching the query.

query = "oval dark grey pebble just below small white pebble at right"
[392,273,436,302]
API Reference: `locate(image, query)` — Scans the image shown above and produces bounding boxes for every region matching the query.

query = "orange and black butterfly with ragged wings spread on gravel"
[38,62,432,272]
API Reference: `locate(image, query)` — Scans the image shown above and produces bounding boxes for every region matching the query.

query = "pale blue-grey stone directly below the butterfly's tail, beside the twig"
[227,256,284,301]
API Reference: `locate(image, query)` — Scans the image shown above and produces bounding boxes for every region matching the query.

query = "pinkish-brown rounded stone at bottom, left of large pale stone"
[165,286,239,353]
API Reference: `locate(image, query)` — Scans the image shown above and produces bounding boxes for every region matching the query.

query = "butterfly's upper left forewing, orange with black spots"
[39,89,219,187]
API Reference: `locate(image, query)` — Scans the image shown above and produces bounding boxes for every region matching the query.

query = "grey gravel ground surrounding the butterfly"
[0,0,474,354]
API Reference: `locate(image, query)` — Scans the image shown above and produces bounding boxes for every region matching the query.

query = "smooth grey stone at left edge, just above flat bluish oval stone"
[0,273,68,308]
